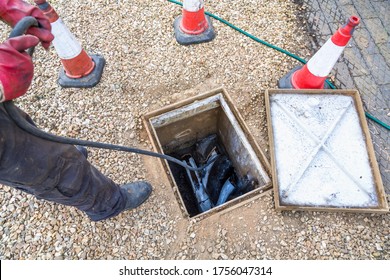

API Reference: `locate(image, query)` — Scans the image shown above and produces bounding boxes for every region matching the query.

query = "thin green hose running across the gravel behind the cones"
[167,0,390,130]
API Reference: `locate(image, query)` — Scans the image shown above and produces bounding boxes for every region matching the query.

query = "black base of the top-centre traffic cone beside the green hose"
[173,15,215,45]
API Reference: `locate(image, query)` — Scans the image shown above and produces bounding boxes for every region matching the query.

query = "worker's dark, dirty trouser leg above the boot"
[0,103,126,221]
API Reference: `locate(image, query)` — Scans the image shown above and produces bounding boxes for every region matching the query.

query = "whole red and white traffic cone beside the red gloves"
[34,0,106,88]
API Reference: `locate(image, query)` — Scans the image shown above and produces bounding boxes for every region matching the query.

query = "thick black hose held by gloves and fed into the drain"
[3,17,215,171]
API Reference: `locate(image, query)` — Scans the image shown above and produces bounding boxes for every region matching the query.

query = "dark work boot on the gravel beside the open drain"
[121,181,152,211]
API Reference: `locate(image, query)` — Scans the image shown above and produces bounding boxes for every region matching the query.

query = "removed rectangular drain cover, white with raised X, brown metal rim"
[265,89,389,213]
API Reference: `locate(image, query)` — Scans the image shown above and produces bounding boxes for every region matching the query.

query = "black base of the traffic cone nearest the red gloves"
[58,54,106,88]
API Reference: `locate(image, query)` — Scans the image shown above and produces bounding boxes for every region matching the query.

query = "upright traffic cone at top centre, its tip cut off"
[173,0,215,45]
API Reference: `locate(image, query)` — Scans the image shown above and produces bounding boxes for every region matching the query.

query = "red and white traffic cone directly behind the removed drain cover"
[278,16,360,89]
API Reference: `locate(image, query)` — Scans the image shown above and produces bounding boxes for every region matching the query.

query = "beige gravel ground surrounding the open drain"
[0,0,390,259]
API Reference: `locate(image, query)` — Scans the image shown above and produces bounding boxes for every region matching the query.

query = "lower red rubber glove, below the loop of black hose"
[0,35,39,102]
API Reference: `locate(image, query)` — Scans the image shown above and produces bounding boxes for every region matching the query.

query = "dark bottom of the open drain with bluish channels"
[169,134,258,217]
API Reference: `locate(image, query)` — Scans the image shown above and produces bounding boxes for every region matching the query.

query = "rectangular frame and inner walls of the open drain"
[143,87,272,219]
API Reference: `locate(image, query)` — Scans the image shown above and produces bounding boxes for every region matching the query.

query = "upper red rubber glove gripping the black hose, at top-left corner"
[0,0,54,49]
